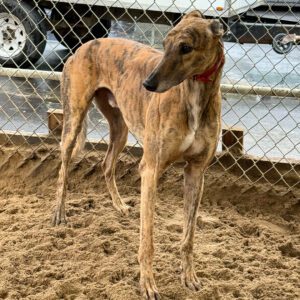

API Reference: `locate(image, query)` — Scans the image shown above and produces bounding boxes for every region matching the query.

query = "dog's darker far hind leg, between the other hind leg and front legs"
[95,88,129,215]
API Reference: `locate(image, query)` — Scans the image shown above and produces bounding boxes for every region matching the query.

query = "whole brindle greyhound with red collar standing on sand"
[53,11,224,300]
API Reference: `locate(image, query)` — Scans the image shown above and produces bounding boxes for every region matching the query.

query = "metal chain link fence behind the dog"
[0,0,300,192]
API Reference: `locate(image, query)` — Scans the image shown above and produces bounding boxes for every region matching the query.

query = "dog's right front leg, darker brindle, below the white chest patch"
[181,162,204,291]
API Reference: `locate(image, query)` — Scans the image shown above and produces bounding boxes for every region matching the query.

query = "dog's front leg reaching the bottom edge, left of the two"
[139,159,159,300]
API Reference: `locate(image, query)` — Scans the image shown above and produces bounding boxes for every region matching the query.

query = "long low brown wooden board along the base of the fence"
[0,131,300,188]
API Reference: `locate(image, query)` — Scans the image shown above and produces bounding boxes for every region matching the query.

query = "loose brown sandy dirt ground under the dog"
[0,146,300,300]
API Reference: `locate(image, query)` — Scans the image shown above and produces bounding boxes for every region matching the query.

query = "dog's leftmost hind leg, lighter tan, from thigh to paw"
[52,74,91,226]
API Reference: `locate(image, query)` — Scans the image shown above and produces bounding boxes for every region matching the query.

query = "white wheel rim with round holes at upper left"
[0,13,27,58]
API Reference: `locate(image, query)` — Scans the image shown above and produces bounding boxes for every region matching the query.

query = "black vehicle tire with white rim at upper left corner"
[0,0,47,68]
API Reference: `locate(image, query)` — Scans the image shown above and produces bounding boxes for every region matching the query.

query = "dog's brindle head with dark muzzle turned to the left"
[143,11,223,93]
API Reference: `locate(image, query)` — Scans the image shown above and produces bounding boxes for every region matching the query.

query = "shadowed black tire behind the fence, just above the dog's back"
[51,8,111,52]
